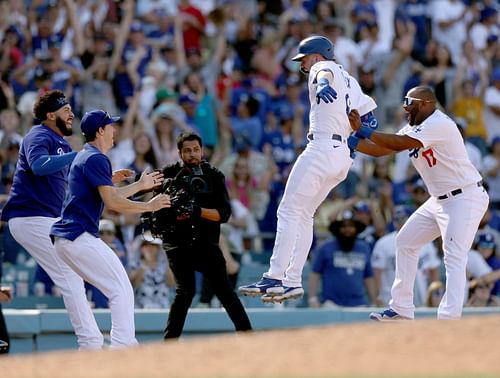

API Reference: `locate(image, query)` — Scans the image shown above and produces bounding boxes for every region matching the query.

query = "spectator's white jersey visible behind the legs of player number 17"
[371,231,441,306]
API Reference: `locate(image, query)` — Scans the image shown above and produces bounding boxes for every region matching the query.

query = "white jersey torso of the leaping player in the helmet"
[309,60,352,138]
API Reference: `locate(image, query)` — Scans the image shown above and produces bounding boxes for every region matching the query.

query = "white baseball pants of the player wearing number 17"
[389,184,489,319]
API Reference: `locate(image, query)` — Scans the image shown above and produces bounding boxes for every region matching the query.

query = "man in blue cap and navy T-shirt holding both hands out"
[50,110,170,348]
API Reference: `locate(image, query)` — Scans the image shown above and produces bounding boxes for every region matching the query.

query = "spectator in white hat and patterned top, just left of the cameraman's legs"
[129,231,175,308]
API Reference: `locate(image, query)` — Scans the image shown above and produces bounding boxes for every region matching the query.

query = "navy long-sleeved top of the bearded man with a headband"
[1,125,71,221]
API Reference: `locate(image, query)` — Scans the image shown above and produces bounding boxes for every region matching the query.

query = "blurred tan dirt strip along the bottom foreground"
[0,316,500,378]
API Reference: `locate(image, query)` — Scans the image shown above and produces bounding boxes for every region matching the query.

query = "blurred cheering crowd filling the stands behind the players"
[0,0,500,308]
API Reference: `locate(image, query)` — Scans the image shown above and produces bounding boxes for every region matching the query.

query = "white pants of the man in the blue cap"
[55,232,137,348]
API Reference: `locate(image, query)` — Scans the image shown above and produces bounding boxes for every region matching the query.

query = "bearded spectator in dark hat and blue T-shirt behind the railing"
[309,210,376,307]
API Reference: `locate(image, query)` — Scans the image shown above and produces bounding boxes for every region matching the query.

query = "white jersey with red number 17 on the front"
[398,109,481,197]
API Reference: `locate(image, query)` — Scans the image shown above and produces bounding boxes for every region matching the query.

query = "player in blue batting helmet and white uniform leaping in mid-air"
[239,36,376,302]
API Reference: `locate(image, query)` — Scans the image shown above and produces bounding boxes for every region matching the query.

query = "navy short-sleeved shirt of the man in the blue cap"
[50,144,113,240]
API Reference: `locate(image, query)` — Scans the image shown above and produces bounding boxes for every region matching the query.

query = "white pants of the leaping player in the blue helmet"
[264,135,352,287]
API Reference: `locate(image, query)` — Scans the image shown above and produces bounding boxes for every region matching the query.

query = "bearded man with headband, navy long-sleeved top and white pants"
[1,90,103,349]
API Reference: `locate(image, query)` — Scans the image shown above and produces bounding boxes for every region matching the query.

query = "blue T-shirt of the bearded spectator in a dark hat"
[312,239,373,306]
